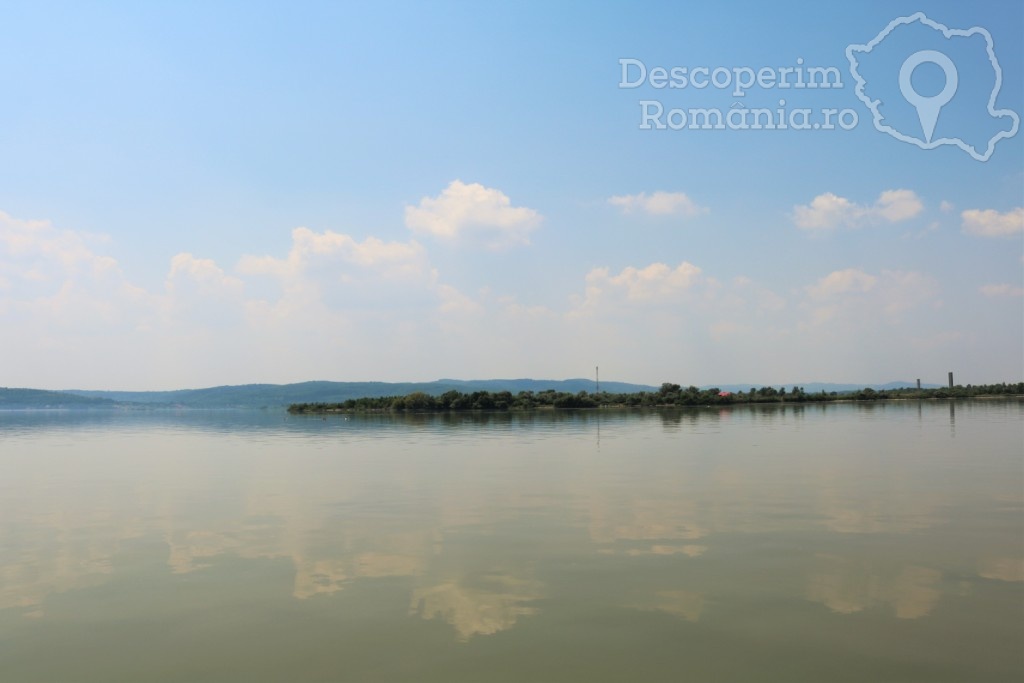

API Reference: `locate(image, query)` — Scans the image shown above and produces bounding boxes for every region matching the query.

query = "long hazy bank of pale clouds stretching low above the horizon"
[0,198,1024,388]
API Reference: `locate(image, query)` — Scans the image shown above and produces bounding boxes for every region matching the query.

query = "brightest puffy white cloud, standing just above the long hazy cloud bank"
[406,180,542,249]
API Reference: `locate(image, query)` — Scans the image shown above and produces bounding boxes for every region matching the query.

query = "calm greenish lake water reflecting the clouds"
[0,400,1024,683]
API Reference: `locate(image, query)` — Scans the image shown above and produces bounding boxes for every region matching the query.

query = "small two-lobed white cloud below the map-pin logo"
[793,189,924,230]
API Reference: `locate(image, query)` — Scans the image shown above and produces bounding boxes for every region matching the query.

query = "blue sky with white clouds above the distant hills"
[0,1,1024,390]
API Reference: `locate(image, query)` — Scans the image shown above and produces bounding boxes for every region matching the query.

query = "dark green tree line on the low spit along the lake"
[288,382,1024,414]
